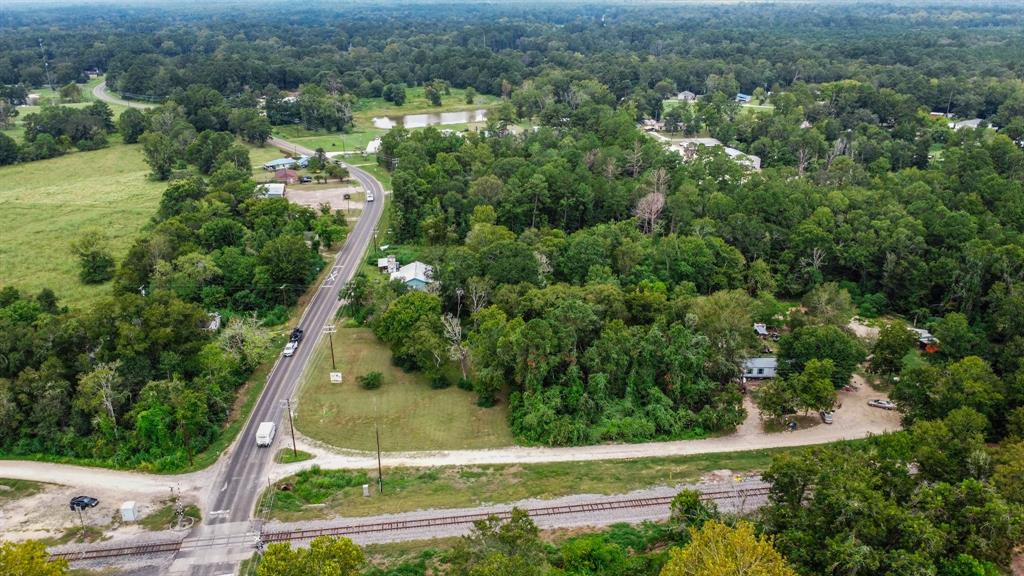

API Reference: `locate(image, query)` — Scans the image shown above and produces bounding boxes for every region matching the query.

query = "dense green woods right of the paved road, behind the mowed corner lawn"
[350,78,1024,444]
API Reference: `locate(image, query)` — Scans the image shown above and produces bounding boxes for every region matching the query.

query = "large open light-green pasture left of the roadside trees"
[0,143,167,307]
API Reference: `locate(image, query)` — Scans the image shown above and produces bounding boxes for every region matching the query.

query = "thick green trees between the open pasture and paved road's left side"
[0,157,345,470]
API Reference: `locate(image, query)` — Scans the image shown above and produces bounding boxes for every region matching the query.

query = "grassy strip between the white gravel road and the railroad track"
[264,449,792,522]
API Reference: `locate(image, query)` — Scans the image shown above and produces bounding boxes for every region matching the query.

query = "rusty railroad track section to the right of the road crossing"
[261,486,769,542]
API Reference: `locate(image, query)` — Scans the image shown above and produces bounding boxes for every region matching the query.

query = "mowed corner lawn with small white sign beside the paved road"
[296,327,513,451]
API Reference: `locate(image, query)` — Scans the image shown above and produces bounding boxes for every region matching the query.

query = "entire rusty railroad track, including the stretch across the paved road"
[50,486,769,562]
